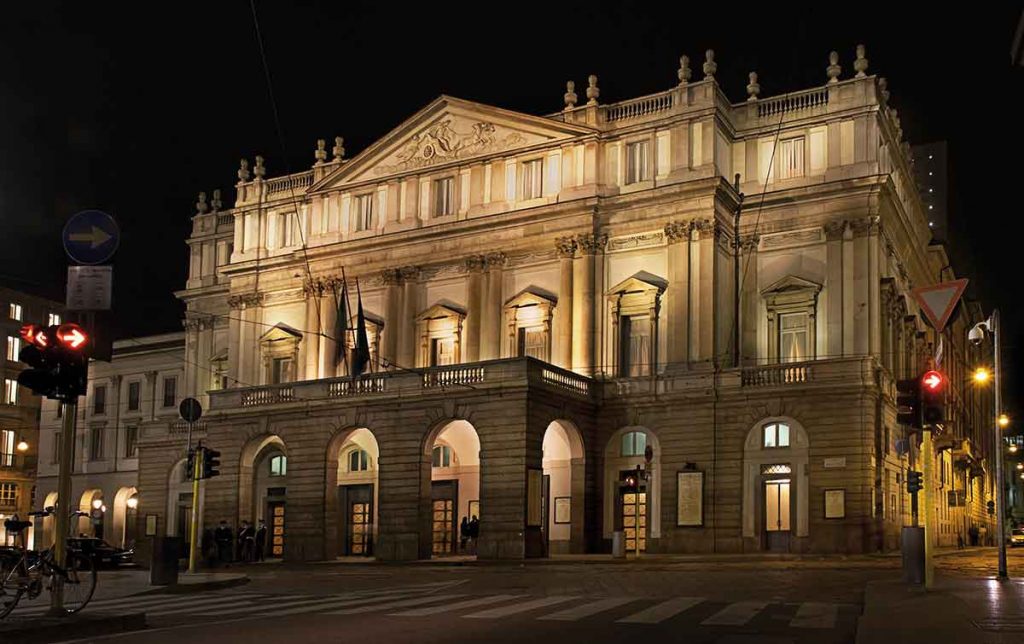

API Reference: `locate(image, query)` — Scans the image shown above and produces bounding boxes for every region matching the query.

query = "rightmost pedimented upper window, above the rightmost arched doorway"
[761,275,821,362]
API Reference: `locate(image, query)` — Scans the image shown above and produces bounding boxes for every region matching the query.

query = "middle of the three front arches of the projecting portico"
[327,427,380,557]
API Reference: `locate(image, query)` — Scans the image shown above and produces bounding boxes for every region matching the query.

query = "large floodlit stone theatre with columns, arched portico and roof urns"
[132,49,992,560]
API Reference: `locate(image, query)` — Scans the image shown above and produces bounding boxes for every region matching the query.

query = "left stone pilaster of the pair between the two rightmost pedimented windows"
[663,221,691,371]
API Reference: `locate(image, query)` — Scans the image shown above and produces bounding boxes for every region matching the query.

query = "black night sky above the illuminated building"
[0,0,1024,407]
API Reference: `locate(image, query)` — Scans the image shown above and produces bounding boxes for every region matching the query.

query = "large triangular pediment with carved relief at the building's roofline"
[309,96,595,192]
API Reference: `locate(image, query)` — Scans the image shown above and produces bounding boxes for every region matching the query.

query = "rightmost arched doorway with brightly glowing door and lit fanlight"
[742,418,809,552]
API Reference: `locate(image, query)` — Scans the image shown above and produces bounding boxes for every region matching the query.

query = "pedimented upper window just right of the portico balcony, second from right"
[607,271,668,378]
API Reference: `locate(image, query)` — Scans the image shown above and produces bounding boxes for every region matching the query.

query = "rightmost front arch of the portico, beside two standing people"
[425,420,482,557]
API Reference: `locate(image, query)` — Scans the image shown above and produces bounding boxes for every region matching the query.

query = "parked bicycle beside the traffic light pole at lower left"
[0,508,96,619]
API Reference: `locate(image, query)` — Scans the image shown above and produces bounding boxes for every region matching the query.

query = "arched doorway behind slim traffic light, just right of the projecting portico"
[603,426,662,553]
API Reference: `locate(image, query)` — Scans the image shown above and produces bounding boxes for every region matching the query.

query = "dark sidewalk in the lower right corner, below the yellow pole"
[856,574,1024,644]
